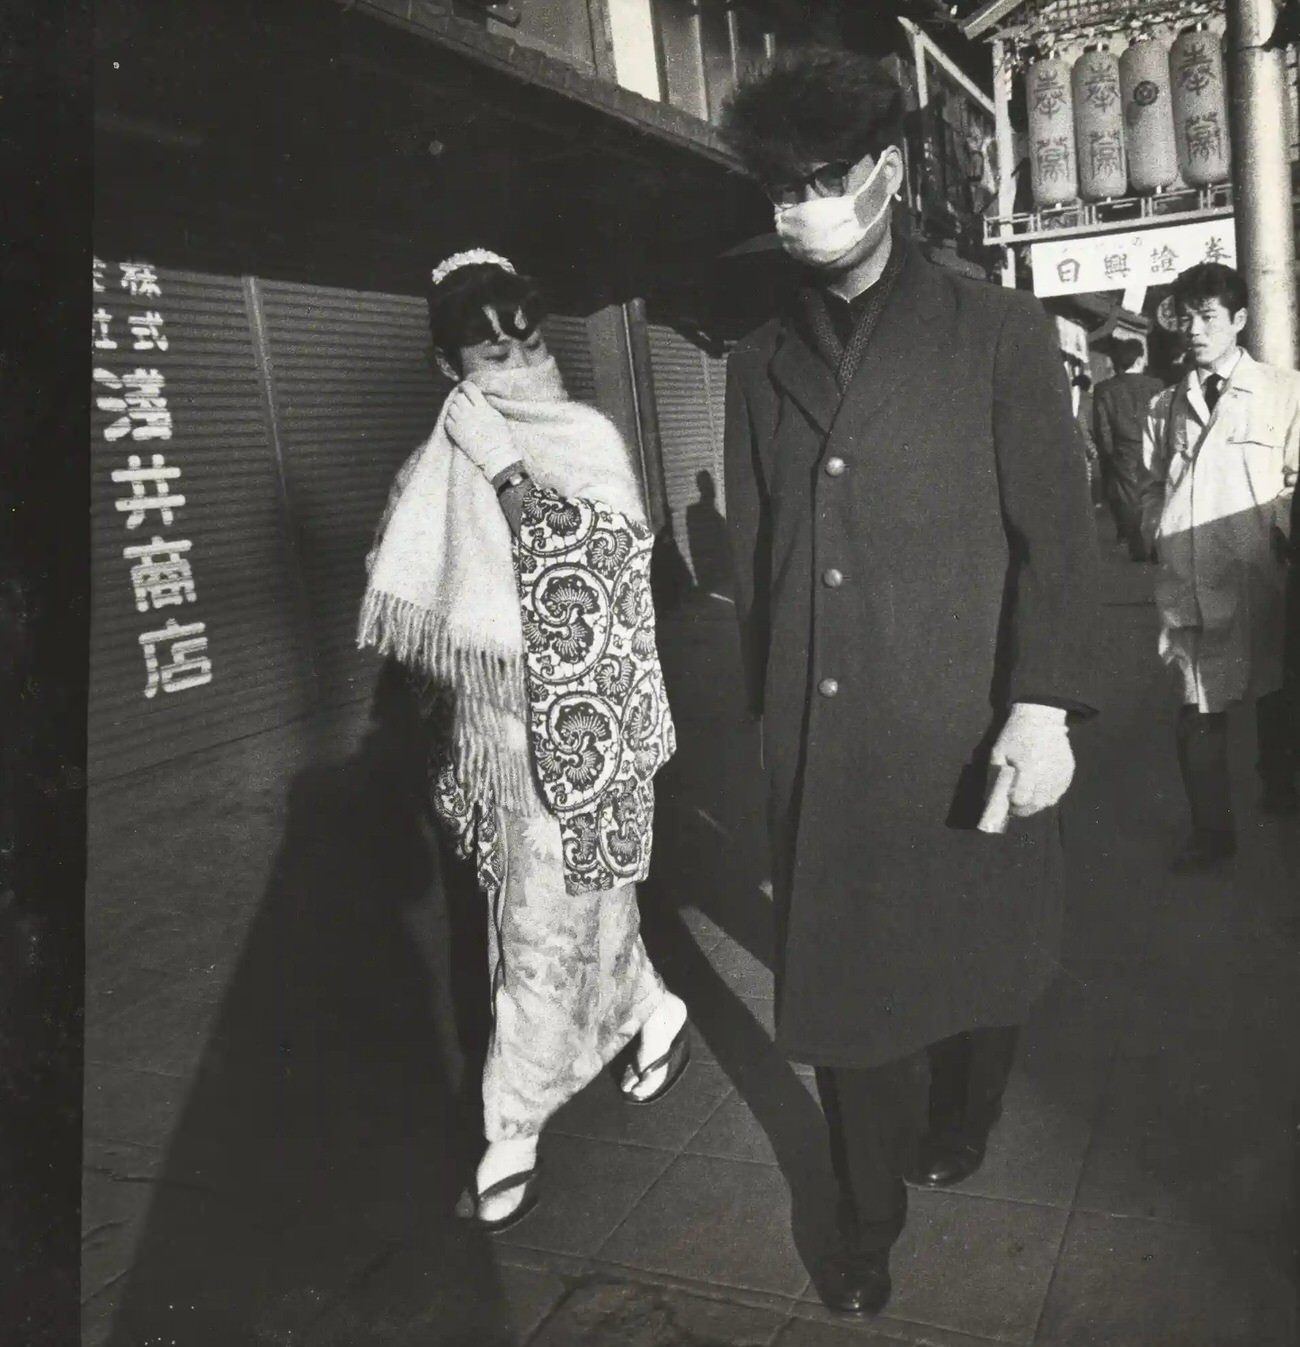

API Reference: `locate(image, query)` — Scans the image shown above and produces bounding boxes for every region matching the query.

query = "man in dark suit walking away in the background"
[1093,338,1164,562]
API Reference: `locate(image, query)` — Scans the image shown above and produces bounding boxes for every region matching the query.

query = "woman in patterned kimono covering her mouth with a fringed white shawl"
[360,249,690,1231]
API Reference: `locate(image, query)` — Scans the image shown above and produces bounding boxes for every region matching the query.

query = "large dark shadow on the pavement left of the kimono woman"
[109,671,515,1347]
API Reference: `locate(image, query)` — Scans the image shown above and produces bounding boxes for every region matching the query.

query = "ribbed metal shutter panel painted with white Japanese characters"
[88,261,310,781]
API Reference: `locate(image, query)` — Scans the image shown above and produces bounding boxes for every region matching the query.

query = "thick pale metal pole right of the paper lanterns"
[1227,0,1297,369]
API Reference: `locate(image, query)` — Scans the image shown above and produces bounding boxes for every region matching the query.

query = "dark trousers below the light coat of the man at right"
[1177,690,1300,835]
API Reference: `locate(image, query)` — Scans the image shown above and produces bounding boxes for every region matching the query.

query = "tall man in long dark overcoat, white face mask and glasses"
[725,51,1097,1313]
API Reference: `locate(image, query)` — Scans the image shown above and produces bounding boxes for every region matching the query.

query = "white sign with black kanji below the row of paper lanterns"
[1029,216,1237,299]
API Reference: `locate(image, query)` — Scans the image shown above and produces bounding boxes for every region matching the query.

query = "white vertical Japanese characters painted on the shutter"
[90,257,213,699]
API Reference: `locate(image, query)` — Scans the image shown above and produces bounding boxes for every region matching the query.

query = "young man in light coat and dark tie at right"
[1142,263,1300,873]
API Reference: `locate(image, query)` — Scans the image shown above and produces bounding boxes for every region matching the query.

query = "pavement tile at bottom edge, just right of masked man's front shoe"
[803,1189,1067,1344]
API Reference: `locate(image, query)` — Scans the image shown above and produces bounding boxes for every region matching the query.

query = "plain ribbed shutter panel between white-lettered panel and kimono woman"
[260,282,439,706]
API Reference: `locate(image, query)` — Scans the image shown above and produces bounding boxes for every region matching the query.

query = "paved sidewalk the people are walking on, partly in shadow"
[84,536,1300,1347]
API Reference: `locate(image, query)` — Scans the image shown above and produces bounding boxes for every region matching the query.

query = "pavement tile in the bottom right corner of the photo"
[1037,1212,1296,1347]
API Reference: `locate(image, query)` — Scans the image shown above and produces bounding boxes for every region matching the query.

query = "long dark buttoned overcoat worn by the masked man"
[726,241,1097,1065]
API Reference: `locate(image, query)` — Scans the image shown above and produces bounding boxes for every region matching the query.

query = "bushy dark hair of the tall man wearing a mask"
[722,47,903,185]
